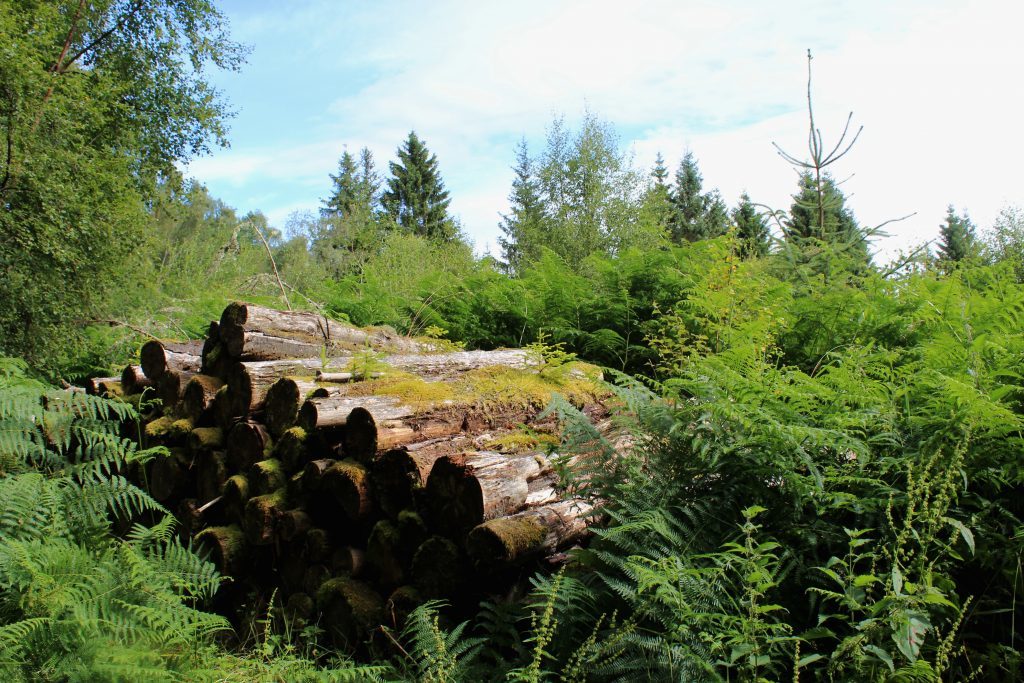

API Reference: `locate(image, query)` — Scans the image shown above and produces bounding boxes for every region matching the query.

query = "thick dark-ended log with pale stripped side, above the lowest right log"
[426,452,550,538]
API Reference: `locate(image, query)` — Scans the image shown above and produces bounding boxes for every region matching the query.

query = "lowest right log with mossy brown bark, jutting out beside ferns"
[466,500,593,566]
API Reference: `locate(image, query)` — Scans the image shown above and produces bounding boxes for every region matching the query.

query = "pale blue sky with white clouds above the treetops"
[187,0,1024,259]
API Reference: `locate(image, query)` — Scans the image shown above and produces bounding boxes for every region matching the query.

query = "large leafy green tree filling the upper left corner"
[0,0,243,368]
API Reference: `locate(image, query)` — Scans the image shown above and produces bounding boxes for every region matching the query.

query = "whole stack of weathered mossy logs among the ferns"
[87,303,603,644]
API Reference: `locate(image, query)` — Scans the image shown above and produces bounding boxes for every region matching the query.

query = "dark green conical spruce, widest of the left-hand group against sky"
[381,131,457,242]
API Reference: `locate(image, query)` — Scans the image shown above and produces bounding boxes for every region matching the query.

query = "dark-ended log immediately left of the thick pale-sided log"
[371,434,472,517]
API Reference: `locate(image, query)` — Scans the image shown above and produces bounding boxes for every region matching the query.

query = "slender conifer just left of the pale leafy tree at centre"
[498,139,548,272]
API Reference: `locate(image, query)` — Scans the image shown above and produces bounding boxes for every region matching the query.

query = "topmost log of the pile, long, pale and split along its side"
[220,303,433,357]
